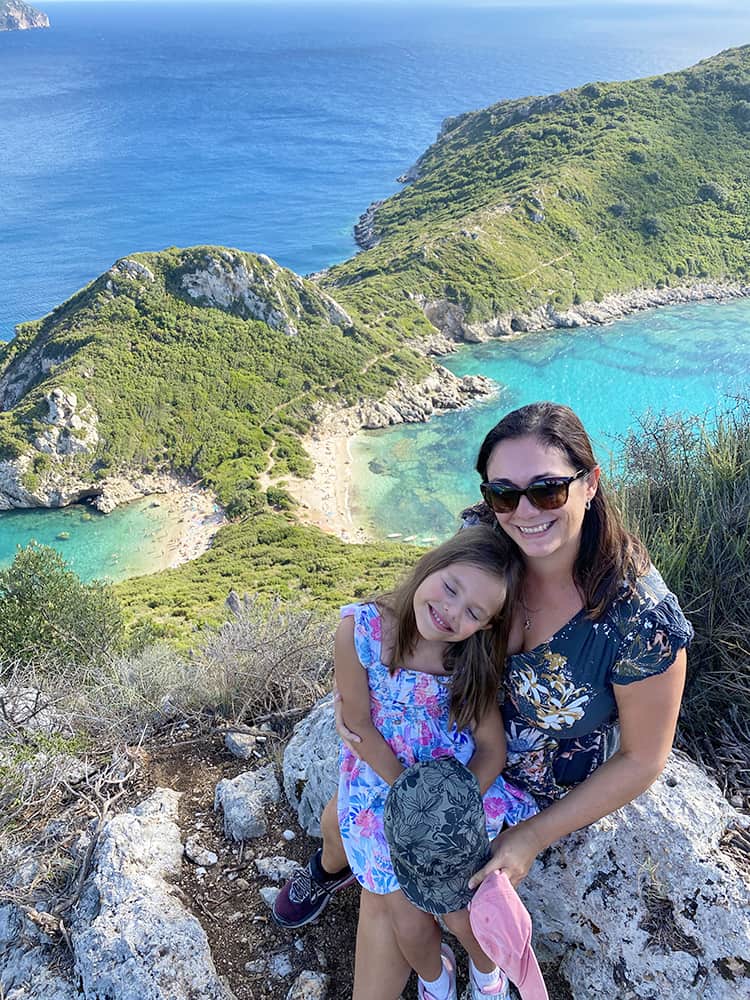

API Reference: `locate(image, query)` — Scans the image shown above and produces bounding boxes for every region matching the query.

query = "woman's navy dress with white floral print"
[502,567,693,805]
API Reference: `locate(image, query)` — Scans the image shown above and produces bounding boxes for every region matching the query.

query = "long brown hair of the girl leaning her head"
[376,525,522,729]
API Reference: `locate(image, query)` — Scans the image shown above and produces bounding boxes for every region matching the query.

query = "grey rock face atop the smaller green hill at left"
[179,250,352,337]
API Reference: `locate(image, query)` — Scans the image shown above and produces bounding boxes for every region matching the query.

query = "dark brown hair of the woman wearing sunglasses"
[476,403,651,620]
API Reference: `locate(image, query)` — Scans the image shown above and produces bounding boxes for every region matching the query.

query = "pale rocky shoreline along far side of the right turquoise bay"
[418,281,750,344]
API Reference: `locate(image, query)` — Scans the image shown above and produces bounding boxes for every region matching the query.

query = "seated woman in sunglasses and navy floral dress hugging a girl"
[275,403,692,1000]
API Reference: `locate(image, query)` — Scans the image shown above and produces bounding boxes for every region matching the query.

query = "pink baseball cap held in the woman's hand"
[469,872,549,1000]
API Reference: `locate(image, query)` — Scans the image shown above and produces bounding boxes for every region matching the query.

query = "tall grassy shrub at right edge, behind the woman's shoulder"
[619,400,750,793]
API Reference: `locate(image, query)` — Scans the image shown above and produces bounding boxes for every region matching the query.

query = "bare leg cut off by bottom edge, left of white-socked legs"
[352,889,411,1000]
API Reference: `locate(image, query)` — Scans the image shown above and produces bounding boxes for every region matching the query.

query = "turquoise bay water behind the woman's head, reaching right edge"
[350,300,750,541]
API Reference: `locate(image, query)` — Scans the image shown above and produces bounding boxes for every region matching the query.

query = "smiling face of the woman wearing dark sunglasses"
[487,435,599,565]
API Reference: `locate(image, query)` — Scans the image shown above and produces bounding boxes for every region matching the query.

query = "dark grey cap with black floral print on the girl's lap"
[383,757,490,913]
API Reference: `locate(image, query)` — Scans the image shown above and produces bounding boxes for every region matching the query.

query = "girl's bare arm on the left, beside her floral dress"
[333,616,404,785]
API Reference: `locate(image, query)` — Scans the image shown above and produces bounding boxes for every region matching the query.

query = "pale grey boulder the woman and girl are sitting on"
[284,696,750,1000]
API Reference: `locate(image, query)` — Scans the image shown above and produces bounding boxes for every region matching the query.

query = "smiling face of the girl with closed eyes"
[414,563,506,642]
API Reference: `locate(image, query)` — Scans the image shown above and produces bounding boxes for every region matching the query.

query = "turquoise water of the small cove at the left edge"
[0,497,185,581]
